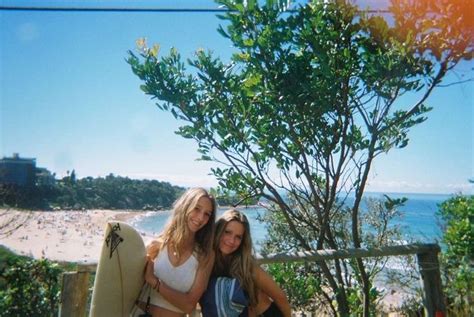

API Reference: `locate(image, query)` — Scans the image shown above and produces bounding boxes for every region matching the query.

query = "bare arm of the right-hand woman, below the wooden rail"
[255,266,291,317]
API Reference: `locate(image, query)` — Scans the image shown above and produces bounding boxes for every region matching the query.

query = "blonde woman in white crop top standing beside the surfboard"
[138,188,216,317]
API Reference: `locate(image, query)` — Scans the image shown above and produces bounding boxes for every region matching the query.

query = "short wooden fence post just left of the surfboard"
[59,272,90,317]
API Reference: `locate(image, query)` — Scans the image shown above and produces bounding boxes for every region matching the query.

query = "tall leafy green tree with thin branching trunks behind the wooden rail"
[128,0,473,316]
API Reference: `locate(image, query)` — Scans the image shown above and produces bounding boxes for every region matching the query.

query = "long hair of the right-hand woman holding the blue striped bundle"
[213,209,258,306]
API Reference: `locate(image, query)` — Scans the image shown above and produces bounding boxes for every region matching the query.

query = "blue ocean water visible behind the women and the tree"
[133,193,453,251]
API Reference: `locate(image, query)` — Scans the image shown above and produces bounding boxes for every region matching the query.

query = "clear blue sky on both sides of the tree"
[0,0,474,194]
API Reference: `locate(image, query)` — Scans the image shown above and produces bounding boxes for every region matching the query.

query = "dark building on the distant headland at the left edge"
[0,153,55,186]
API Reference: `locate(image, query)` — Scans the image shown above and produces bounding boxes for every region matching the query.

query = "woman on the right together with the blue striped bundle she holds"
[200,209,291,317]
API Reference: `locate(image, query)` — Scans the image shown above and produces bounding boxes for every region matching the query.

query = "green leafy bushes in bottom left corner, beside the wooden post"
[0,247,63,317]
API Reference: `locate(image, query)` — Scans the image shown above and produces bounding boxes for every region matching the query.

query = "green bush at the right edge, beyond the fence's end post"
[439,196,474,316]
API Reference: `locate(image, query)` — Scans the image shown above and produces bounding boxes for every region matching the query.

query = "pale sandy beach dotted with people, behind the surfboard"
[0,209,152,264]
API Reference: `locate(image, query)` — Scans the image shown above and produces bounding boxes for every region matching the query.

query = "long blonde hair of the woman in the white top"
[159,187,216,262]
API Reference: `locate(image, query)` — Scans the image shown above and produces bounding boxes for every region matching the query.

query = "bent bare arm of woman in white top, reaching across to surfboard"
[145,254,214,314]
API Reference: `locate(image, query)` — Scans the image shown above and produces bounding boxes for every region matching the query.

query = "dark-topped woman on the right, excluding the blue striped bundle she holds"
[201,209,291,317]
